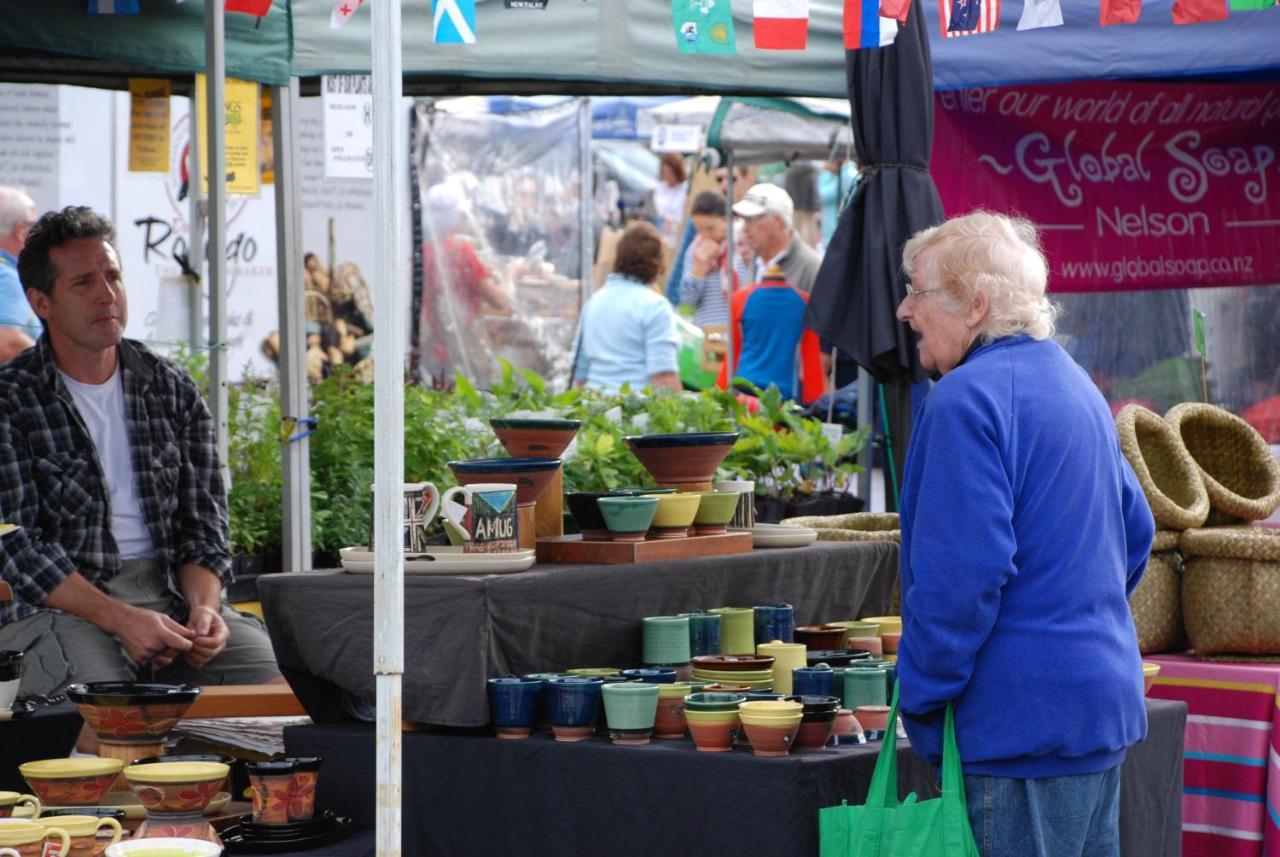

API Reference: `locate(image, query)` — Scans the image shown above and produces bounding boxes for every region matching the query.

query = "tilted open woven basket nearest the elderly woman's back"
[1116,404,1208,530]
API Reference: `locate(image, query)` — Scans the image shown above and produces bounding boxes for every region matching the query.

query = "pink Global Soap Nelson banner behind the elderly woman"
[932,81,1280,292]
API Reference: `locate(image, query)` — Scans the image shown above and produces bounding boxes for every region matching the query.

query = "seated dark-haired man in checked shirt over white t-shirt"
[0,207,282,748]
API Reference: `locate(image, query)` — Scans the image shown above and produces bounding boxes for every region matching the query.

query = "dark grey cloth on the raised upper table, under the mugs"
[259,542,897,727]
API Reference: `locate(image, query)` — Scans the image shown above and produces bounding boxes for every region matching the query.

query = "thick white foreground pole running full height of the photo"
[369,0,408,857]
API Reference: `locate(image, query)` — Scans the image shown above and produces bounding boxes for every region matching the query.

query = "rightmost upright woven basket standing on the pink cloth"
[1179,527,1280,656]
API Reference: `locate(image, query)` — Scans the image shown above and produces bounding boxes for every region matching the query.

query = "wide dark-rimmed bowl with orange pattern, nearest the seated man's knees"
[67,682,200,744]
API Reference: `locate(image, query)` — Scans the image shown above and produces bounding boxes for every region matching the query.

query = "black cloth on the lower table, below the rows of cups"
[284,700,1187,857]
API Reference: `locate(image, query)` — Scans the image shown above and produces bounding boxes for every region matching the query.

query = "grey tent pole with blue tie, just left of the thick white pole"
[271,78,311,572]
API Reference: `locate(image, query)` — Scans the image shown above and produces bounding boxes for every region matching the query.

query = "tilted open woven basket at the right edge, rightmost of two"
[1165,402,1280,523]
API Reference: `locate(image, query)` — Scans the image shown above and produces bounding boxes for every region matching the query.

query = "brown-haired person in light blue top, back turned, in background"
[573,220,681,393]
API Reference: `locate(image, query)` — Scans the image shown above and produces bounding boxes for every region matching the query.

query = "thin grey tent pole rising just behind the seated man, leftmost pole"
[203,0,232,490]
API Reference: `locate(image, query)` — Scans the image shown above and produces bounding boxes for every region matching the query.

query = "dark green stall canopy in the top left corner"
[0,0,290,90]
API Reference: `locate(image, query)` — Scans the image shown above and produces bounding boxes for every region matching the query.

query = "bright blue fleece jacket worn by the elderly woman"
[897,336,1155,778]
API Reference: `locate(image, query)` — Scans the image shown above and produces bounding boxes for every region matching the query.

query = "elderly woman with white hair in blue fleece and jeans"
[897,211,1155,857]
